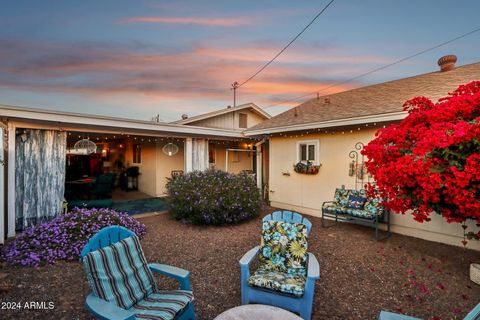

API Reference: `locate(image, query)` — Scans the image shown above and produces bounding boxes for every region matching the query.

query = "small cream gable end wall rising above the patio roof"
[188,109,264,130]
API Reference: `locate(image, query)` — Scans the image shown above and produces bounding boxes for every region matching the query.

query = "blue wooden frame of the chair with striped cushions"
[80,226,195,320]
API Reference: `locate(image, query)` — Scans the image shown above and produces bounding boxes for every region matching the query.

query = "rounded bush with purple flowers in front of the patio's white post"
[167,170,263,225]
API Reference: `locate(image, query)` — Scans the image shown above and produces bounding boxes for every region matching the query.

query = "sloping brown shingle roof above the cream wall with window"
[245,62,480,135]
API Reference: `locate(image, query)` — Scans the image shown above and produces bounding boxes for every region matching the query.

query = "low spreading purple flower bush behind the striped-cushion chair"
[1,208,146,266]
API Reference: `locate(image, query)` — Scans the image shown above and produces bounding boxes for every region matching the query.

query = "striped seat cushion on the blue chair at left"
[129,290,193,320]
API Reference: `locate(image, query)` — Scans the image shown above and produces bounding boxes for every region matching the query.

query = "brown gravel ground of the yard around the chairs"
[0,210,480,320]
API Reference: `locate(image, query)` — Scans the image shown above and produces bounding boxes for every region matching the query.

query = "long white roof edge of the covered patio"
[0,105,243,138]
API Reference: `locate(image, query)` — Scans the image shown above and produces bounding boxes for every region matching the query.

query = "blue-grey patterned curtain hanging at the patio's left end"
[15,129,67,230]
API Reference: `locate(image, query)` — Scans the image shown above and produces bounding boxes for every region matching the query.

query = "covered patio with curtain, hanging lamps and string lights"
[0,106,262,242]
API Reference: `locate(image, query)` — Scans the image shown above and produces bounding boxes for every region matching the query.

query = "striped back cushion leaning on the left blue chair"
[82,236,158,309]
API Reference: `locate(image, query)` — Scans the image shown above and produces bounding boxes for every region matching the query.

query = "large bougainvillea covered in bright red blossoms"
[362,81,480,230]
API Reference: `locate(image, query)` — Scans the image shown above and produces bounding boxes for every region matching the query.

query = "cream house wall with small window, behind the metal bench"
[269,129,480,250]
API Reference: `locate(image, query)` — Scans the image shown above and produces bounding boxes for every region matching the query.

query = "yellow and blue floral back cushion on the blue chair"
[259,221,308,272]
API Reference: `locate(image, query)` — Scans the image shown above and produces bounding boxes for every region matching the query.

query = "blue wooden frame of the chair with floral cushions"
[240,211,320,320]
